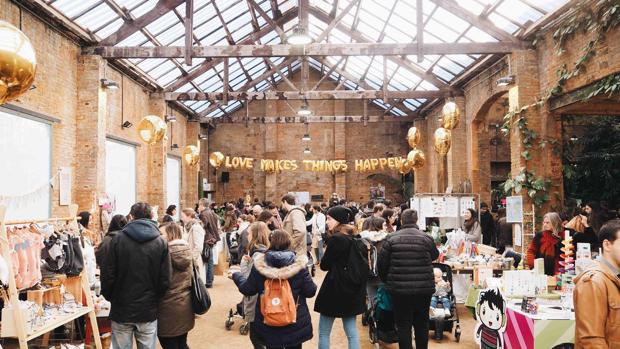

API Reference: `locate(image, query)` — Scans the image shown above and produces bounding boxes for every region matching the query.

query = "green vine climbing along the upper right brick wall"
[502,0,620,208]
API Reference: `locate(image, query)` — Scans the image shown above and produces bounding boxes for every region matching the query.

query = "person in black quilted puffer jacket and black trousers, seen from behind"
[377,209,439,349]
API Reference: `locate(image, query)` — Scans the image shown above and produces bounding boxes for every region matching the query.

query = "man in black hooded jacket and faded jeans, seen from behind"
[101,203,172,349]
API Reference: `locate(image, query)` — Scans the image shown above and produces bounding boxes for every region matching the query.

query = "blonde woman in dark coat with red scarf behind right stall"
[527,212,562,276]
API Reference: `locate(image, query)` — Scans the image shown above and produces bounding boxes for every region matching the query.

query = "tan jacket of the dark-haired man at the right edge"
[573,261,620,349]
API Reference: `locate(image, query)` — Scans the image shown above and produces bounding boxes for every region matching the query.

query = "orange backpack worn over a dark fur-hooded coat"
[260,279,297,327]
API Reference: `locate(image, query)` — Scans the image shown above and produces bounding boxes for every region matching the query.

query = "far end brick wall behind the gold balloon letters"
[202,72,410,202]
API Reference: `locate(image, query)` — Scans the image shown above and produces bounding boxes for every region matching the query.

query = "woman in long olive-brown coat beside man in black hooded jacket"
[157,222,194,349]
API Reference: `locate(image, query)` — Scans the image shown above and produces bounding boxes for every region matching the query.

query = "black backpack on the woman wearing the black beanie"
[334,238,370,295]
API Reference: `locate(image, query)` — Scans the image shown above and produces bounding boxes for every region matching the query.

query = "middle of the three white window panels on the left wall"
[105,139,136,215]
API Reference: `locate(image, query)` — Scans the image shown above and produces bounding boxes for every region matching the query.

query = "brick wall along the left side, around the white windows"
[0,0,198,222]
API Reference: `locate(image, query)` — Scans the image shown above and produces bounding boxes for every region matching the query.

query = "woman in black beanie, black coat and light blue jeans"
[314,206,368,349]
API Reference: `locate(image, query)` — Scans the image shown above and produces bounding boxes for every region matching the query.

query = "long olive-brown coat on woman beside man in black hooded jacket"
[157,240,194,337]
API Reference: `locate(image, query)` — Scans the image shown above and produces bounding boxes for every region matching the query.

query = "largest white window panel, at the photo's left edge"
[0,110,55,220]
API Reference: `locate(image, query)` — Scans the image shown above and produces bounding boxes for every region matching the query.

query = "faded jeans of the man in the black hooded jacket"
[112,320,157,349]
